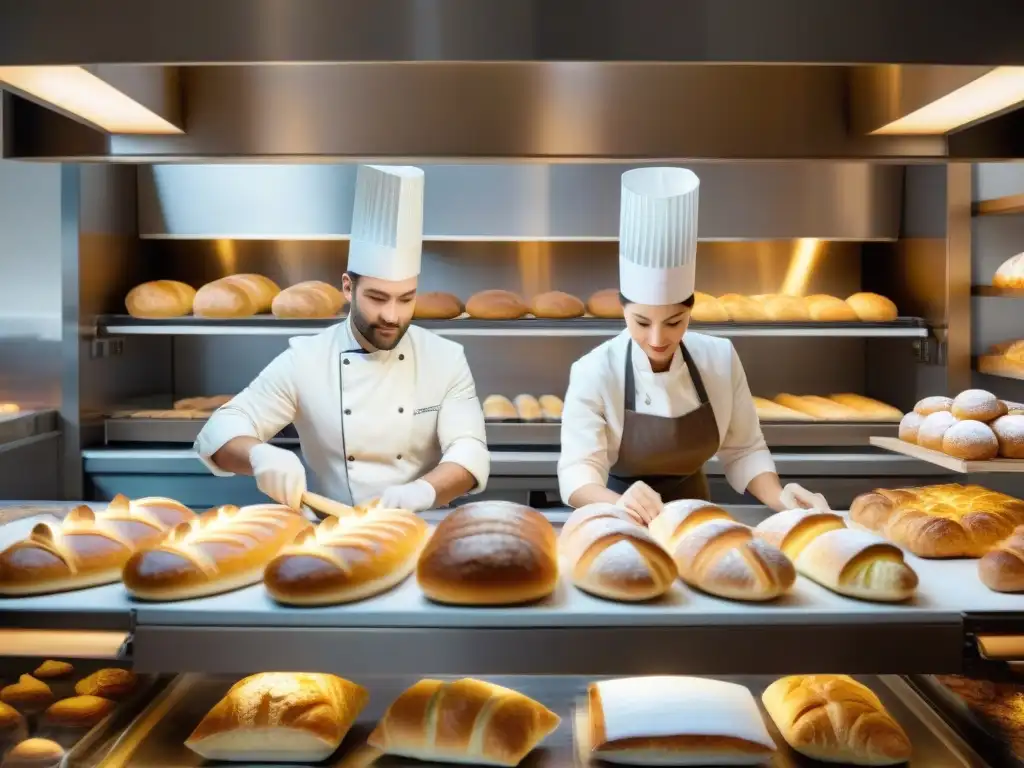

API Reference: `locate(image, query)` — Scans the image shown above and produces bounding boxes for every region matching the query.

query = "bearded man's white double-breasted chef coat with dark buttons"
[196,321,490,504]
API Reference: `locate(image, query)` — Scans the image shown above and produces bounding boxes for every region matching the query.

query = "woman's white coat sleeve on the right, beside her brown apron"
[718,347,775,494]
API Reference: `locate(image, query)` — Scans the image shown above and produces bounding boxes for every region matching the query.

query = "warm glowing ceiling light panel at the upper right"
[871,67,1024,134]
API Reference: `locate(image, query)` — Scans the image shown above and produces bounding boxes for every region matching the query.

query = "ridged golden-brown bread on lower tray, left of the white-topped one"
[368,679,559,766]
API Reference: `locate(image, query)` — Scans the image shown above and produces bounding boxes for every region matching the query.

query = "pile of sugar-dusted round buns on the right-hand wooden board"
[899,389,1024,461]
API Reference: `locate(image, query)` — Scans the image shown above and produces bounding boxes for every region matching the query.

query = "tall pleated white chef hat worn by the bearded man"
[348,165,423,281]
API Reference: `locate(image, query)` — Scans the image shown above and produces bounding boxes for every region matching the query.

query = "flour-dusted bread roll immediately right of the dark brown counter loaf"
[558,504,676,601]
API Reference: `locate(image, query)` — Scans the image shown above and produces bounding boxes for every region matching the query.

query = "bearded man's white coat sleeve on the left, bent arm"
[195,348,298,477]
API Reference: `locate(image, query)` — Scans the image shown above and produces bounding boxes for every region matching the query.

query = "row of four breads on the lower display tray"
[174,672,911,767]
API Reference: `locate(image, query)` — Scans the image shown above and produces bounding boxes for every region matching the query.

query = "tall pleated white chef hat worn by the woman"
[618,168,700,305]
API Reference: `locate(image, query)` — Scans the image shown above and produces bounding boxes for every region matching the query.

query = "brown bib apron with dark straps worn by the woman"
[608,341,721,502]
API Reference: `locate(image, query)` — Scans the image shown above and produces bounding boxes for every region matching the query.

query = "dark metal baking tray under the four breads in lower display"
[68,675,984,768]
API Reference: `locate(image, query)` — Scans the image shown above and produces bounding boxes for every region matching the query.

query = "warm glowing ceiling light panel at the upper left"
[0,67,184,134]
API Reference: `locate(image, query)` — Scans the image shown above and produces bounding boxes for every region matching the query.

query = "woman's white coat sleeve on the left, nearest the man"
[558,360,611,506]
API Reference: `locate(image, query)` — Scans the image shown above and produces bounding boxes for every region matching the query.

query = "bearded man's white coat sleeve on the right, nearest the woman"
[437,354,490,494]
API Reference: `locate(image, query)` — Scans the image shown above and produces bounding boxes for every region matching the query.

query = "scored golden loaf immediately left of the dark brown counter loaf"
[263,507,430,605]
